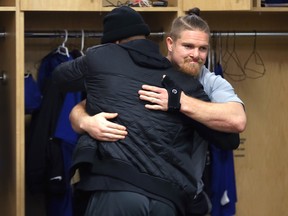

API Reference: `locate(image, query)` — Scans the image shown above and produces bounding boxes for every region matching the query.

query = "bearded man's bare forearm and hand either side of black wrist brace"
[138,84,247,133]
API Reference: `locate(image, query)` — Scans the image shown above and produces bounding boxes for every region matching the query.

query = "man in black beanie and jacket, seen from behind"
[53,6,239,216]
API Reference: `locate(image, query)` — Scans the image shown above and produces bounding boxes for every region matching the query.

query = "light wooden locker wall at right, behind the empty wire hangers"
[203,12,288,216]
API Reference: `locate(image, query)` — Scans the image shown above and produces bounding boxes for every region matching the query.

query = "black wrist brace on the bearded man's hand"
[162,76,182,112]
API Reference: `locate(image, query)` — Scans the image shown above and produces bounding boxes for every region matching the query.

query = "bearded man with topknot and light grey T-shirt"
[138,9,246,136]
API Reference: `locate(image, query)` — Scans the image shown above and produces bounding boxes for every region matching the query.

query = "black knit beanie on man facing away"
[101,6,150,44]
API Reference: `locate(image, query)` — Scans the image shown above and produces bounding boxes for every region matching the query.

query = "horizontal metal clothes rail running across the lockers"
[0,31,288,38]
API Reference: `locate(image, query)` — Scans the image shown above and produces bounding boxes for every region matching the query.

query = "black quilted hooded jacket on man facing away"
[54,40,239,212]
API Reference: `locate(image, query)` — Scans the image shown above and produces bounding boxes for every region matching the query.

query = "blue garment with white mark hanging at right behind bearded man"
[210,63,237,216]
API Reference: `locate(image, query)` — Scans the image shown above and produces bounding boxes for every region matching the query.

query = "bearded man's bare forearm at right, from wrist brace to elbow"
[180,92,246,133]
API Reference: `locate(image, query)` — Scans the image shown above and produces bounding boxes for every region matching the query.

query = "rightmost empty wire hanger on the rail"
[244,32,266,79]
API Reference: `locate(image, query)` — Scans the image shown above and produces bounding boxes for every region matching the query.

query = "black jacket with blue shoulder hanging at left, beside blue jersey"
[26,51,71,193]
